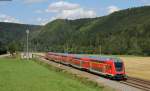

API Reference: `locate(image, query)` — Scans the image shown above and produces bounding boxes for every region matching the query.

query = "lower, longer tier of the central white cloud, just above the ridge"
[37,8,96,25]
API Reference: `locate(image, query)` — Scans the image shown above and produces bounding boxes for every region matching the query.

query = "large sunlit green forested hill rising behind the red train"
[32,6,150,55]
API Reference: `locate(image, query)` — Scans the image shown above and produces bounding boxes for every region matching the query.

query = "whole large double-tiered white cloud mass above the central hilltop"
[37,1,97,25]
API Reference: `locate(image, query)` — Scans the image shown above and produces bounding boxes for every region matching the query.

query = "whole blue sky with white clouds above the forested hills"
[0,0,150,25]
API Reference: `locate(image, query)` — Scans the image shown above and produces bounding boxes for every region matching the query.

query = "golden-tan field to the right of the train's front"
[120,56,150,80]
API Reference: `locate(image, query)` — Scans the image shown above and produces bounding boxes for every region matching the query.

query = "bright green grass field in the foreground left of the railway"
[0,58,108,91]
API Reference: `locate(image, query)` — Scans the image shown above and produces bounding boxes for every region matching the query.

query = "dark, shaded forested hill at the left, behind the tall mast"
[0,22,41,53]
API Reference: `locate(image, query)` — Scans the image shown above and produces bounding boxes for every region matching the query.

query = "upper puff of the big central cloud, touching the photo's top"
[46,1,80,12]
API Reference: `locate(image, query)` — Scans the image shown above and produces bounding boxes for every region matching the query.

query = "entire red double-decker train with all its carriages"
[45,52,127,80]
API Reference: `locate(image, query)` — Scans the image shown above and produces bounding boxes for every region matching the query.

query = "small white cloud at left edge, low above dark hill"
[0,14,20,23]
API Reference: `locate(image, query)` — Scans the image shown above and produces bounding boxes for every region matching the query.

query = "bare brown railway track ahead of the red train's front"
[120,77,150,91]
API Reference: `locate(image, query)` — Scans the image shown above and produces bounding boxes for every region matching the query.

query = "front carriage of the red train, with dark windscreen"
[90,57,126,79]
